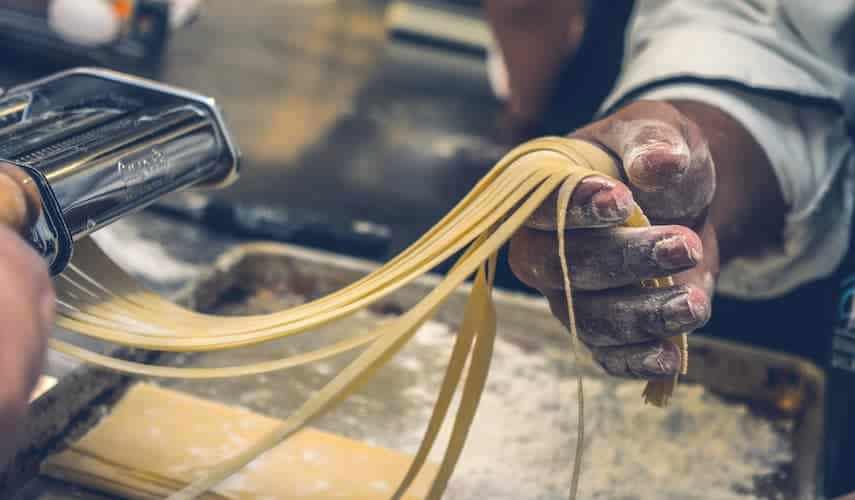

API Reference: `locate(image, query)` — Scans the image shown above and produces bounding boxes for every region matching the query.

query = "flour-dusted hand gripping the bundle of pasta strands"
[510,101,719,379]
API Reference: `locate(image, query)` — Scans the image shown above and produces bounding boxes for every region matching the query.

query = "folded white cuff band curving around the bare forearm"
[640,84,855,298]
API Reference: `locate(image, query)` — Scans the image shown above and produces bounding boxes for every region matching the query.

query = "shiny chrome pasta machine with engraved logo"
[0,69,239,274]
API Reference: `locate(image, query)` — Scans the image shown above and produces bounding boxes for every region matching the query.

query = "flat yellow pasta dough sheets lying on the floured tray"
[42,383,437,500]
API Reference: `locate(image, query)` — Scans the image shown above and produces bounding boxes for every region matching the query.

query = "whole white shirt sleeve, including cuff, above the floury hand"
[606,0,855,298]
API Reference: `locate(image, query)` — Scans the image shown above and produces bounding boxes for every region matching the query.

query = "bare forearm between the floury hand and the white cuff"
[669,100,787,263]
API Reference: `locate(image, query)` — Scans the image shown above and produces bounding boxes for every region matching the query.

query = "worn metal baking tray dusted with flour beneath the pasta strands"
[16,213,822,500]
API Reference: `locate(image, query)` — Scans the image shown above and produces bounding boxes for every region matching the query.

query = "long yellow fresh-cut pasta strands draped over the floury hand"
[51,138,688,500]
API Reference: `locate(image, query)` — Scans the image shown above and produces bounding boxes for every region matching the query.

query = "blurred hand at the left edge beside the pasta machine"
[0,166,55,464]
